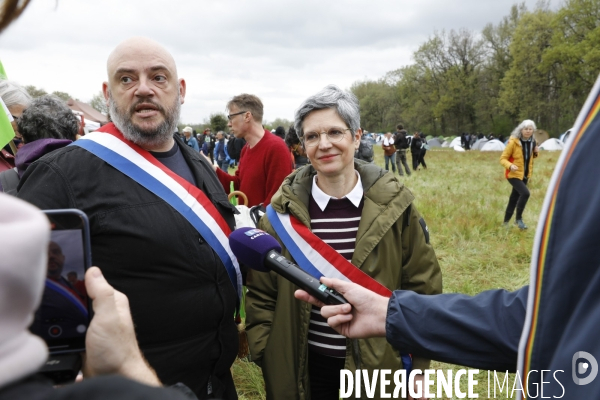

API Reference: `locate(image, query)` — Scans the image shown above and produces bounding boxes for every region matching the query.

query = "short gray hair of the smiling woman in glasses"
[294,85,360,139]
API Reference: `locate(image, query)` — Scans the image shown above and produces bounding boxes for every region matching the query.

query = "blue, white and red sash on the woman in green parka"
[267,205,392,297]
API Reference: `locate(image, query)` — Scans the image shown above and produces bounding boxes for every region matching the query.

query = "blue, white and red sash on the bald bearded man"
[71,123,242,297]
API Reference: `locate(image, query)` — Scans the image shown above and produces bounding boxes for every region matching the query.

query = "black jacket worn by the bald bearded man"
[18,136,238,399]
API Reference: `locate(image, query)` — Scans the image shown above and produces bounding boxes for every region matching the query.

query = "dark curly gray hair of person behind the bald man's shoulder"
[17,95,79,143]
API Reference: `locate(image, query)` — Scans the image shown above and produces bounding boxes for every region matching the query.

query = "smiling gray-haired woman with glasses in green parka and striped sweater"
[246,86,442,400]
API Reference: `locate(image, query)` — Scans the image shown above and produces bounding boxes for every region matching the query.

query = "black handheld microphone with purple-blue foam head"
[229,228,348,305]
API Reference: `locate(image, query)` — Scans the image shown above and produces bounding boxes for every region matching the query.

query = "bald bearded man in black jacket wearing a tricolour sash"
[18,38,241,399]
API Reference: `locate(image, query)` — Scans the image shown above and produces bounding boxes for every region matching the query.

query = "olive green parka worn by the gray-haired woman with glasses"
[246,161,442,400]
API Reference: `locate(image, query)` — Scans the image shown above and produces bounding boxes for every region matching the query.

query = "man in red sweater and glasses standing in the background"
[213,94,293,207]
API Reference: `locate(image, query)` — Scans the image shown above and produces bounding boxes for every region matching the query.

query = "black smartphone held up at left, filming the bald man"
[29,209,92,355]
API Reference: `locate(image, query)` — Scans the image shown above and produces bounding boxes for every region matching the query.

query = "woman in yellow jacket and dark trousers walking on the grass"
[500,119,538,230]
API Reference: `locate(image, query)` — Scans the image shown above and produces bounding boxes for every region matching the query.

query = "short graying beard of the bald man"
[108,92,181,149]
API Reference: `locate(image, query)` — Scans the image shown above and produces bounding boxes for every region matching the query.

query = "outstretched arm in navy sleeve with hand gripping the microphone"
[294,278,528,371]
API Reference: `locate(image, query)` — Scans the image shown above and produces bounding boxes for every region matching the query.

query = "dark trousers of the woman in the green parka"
[308,351,346,400]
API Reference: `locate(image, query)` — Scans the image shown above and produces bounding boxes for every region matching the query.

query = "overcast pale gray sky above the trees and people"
[0,0,558,123]
